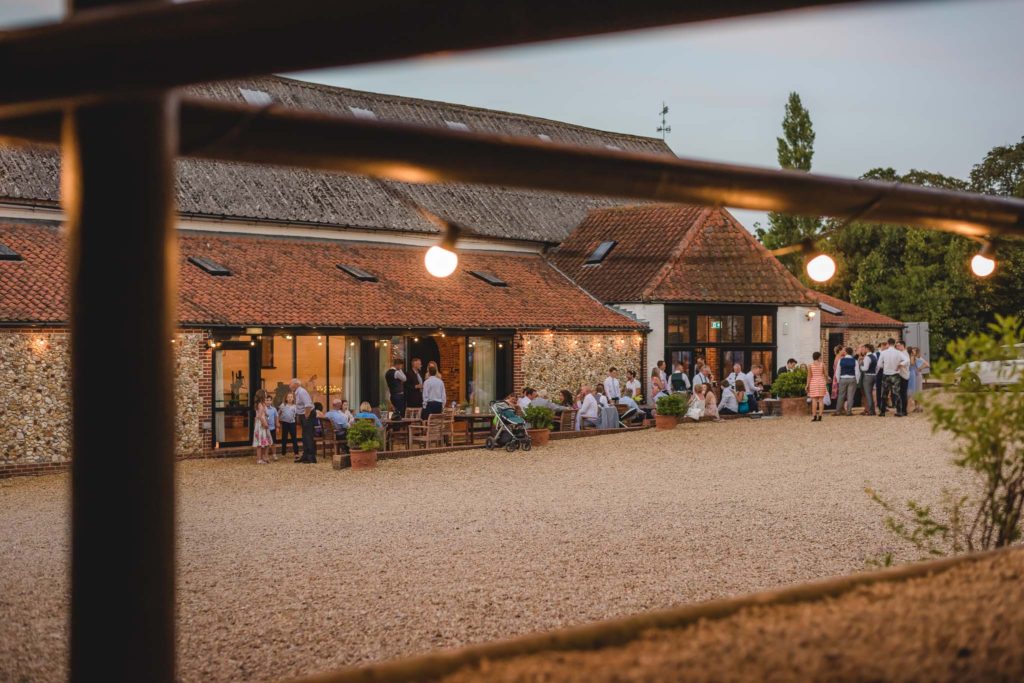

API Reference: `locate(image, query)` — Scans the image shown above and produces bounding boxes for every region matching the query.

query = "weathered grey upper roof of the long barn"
[0,77,672,243]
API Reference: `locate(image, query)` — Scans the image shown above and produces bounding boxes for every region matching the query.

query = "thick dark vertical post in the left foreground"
[61,0,177,683]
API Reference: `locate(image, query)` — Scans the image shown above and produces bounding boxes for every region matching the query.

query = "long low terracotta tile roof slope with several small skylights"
[0,224,644,330]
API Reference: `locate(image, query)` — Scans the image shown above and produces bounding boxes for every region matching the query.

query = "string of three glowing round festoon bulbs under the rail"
[418,207,995,283]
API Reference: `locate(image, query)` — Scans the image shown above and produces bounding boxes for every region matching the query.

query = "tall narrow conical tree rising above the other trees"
[756,92,821,279]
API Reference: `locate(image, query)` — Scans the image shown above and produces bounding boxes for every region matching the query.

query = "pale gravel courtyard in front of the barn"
[0,416,963,681]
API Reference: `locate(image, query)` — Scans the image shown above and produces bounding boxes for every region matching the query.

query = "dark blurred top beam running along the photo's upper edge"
[0,0,906,115]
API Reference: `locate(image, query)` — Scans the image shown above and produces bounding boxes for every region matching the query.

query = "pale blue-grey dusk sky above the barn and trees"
[0,0,1024,231]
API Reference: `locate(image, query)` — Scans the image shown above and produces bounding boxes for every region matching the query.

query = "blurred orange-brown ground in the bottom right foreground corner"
[443,550,1024,683]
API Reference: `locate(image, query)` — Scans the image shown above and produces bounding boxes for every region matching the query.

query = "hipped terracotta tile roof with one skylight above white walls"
[552,204,813,305]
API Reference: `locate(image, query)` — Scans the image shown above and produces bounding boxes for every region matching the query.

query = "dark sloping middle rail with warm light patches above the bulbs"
[0,99,1024,238]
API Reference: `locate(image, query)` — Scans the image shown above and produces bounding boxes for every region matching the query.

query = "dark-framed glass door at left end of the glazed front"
[213,342,259,447]
